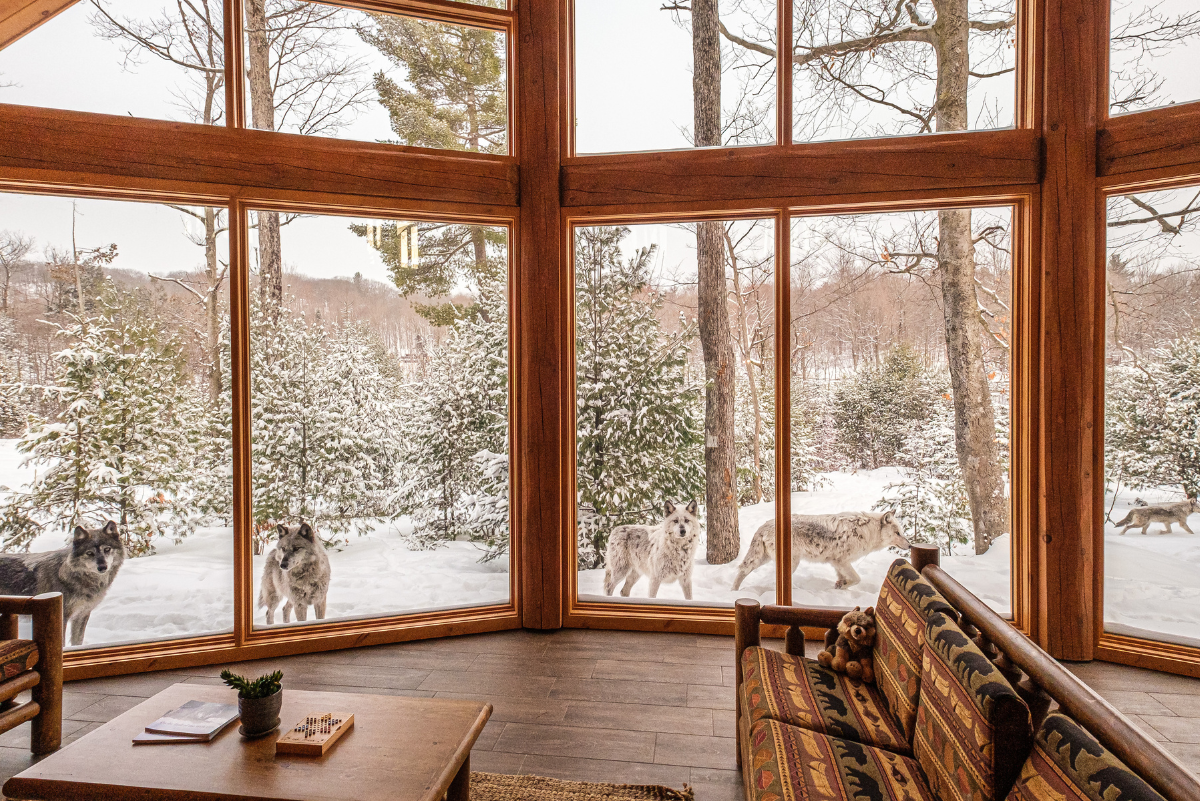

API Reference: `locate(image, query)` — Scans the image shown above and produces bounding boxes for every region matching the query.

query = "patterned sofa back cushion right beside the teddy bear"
[874,559,958,742]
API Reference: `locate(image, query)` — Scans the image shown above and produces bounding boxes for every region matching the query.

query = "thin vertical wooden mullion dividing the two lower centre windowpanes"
[772,211,792,607]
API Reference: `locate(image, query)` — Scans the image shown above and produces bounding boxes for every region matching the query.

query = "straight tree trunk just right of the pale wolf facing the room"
[691,0,742,565]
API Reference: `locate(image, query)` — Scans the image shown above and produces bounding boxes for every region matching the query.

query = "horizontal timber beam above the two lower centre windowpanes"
[562,131,1042,209]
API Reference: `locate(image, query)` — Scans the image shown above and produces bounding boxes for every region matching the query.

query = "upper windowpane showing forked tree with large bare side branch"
[792,0,1016,141]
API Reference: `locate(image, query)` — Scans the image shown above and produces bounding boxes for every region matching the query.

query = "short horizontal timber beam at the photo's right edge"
[1098,103,1200,177]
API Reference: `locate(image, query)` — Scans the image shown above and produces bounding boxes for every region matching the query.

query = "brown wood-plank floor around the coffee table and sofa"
[0,630,1200,801]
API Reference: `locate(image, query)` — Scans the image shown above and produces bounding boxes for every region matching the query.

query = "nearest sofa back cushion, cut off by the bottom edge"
[1008,712,1163,801]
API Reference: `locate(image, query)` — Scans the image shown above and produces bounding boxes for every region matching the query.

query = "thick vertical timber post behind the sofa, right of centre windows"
[1036,0,1105,660]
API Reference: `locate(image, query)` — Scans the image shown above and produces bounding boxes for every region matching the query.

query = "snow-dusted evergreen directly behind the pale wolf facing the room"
[575,227,704,568]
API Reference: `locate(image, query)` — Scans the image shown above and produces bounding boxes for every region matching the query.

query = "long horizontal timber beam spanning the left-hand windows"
[0,106,518,206]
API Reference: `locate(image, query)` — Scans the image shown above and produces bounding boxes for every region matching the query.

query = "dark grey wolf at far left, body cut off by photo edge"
[0,520,125,645]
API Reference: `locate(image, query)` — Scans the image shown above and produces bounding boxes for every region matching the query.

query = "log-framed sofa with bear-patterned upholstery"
[737,548,1200,801]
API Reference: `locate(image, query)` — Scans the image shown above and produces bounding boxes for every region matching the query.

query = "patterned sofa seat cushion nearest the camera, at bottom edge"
[742,719,936,801]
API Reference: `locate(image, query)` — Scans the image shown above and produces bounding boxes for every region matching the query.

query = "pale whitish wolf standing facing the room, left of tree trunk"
[604,501,700,601]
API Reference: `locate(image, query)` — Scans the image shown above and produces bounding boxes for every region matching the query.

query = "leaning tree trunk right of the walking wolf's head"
[934,0,1008,554]
